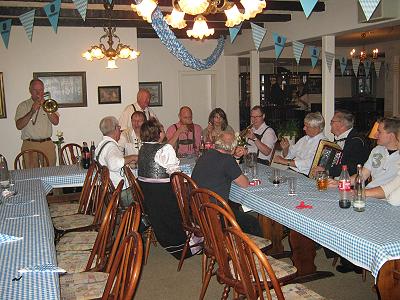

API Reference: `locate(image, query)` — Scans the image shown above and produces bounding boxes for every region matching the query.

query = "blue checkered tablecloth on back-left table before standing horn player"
[11,165,87,189]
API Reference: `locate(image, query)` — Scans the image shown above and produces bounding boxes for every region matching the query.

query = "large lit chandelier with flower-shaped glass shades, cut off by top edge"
[131,0,266,39]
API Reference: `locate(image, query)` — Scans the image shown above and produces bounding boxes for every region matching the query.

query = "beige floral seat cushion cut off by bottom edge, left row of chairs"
[60,272,108,300]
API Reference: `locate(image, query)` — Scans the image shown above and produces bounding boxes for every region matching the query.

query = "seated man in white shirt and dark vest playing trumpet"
[246,105,277,165]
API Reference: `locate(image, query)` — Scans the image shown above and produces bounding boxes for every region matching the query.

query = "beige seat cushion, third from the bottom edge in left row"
[56,231,98,252]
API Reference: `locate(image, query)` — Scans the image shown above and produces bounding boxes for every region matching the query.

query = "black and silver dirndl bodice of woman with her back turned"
[138,143,169,179]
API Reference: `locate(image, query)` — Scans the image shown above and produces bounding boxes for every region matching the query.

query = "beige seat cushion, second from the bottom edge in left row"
[57,251,92,273]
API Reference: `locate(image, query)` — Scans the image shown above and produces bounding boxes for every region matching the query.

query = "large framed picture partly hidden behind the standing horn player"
[33,72,87,108]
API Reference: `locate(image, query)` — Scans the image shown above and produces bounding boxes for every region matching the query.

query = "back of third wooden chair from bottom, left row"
[85,180,124,272]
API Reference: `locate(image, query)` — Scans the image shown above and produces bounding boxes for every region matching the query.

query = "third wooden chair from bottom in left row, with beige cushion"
[57,180,124,273]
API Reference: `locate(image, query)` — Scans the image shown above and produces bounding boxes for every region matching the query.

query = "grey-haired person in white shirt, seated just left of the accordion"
[273,112,326,175]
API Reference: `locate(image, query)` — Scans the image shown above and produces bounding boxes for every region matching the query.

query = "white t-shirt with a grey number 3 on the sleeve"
[364,145,400,188]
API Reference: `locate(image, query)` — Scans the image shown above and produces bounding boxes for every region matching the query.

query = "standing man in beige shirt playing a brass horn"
[15,79,60,168]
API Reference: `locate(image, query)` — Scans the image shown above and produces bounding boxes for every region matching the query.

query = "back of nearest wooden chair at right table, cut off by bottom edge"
[224,227,285,300]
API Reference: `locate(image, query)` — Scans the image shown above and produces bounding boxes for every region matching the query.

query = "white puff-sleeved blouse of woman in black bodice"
[138,142,180,182]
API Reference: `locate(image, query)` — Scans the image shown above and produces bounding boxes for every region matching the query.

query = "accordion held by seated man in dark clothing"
[308,140,342,178]
